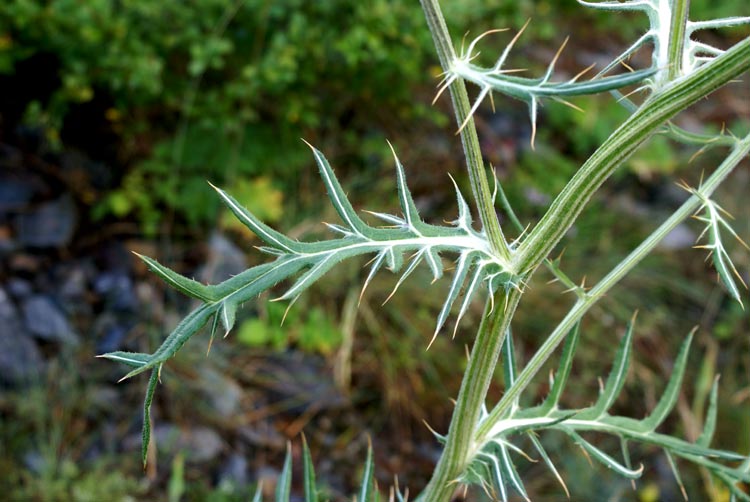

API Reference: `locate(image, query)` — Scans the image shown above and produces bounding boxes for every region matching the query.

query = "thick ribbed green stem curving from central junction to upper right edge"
[513,37,750,273]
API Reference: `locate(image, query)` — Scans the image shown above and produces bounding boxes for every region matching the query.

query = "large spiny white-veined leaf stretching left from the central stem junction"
[108,147,514,470]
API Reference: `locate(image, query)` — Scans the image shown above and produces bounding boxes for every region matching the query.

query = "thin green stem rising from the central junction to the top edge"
[421,0,510,262]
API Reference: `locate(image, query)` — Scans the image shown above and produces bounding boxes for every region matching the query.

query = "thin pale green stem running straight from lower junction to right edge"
[476,134,750,442]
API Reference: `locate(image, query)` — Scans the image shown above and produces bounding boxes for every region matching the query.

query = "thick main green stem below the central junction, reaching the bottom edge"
[424,289,521,502]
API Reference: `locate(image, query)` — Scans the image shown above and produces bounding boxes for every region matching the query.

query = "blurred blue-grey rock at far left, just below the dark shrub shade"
[14,194,77,248]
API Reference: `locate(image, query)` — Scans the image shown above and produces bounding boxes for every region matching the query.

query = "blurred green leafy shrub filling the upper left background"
[0,0,444,231]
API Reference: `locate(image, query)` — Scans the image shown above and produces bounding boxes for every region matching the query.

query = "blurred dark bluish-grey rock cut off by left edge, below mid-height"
[0,288,44,385]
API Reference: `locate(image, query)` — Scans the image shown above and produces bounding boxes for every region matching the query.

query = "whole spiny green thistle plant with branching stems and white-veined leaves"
[103,0,750,501]
